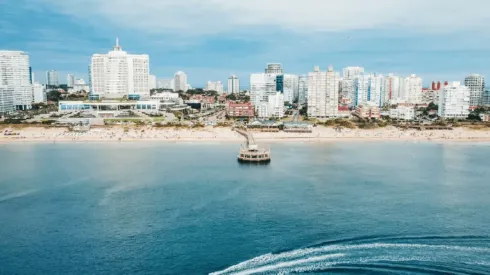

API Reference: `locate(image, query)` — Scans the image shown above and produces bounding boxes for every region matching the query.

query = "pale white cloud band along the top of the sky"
[38,0,490,36]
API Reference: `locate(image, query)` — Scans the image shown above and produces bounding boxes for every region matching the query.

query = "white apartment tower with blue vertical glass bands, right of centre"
[354,74,385,107]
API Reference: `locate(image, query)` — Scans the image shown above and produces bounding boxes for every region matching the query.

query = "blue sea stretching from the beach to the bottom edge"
[0,142,490,274]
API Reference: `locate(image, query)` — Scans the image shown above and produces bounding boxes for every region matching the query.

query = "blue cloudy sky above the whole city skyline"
[0,0,490,88]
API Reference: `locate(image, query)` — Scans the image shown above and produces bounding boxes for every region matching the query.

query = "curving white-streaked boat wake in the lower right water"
[210,236,490,275]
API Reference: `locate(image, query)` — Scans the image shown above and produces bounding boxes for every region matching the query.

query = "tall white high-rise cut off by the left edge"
[0,51,33,110]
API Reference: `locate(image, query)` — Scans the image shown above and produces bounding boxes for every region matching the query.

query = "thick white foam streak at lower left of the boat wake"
[210,253,345,275]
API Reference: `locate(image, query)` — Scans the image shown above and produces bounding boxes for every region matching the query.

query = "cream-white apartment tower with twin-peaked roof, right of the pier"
[308,66,340,118]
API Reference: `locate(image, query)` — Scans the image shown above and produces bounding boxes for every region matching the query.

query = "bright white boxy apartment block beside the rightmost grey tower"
[438,82,471,118]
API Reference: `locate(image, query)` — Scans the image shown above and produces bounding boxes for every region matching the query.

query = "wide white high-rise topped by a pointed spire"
[90,39,150,99]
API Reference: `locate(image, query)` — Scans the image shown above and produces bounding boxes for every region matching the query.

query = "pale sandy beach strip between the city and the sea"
[0,127,490,144]
